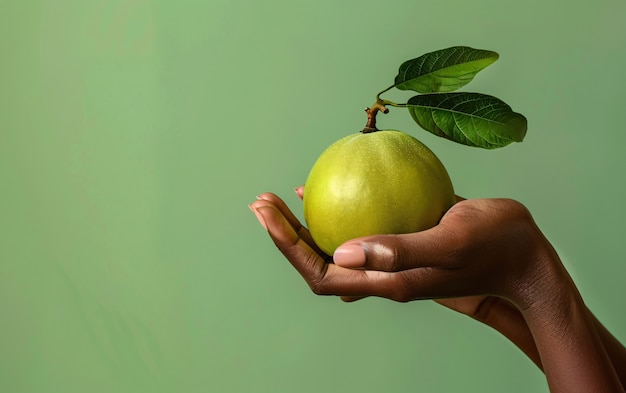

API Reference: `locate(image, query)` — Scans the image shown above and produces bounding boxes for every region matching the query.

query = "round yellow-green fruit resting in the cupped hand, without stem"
[303,130,455,255]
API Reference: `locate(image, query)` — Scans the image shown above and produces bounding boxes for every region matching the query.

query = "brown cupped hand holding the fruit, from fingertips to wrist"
[250,188,549,310]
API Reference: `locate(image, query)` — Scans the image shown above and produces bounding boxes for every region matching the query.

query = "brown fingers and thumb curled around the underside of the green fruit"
[250,191,482,302]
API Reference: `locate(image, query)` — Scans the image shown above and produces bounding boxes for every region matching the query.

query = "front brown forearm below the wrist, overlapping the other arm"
[518,250,624,393]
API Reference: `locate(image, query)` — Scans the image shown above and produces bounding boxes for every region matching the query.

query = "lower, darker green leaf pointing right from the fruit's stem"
[406,93,527,149]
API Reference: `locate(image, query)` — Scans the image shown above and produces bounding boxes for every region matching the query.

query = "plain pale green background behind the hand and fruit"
[0,0,626,393]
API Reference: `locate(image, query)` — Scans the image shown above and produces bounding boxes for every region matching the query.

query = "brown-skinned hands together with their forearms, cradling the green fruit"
[250,188,626,392]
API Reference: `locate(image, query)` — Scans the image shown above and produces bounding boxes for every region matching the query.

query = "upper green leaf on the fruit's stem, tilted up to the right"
[394,46,499,93]
